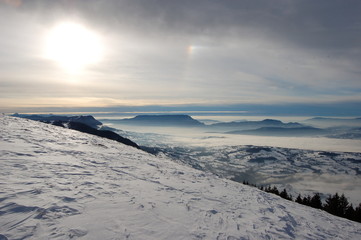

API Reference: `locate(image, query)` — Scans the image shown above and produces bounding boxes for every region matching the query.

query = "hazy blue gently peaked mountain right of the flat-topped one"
[209,119,304,130]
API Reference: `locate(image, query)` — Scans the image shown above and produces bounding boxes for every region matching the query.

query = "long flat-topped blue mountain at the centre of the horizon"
[115,115,204,127]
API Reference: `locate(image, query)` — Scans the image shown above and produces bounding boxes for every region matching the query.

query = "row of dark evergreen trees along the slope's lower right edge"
[243,181,361,223]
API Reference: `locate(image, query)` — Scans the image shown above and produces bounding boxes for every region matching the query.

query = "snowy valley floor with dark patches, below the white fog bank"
[151,145,361,206]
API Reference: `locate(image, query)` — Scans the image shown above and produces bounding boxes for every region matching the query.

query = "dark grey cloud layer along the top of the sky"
[22,0,361,69]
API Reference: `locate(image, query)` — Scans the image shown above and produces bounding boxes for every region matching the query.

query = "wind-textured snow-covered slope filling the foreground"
[0,117,361,240]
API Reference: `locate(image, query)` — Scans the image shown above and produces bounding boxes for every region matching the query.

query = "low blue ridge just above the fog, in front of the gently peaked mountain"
[227,127,328,137]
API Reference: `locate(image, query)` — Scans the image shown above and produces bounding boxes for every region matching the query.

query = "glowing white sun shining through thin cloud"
[45,22,103,73]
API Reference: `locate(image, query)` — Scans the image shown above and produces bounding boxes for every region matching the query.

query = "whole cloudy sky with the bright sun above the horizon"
[0,0,361,116]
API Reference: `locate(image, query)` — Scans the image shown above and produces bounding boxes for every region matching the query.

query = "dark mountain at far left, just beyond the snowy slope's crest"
[12,113,102,128]
